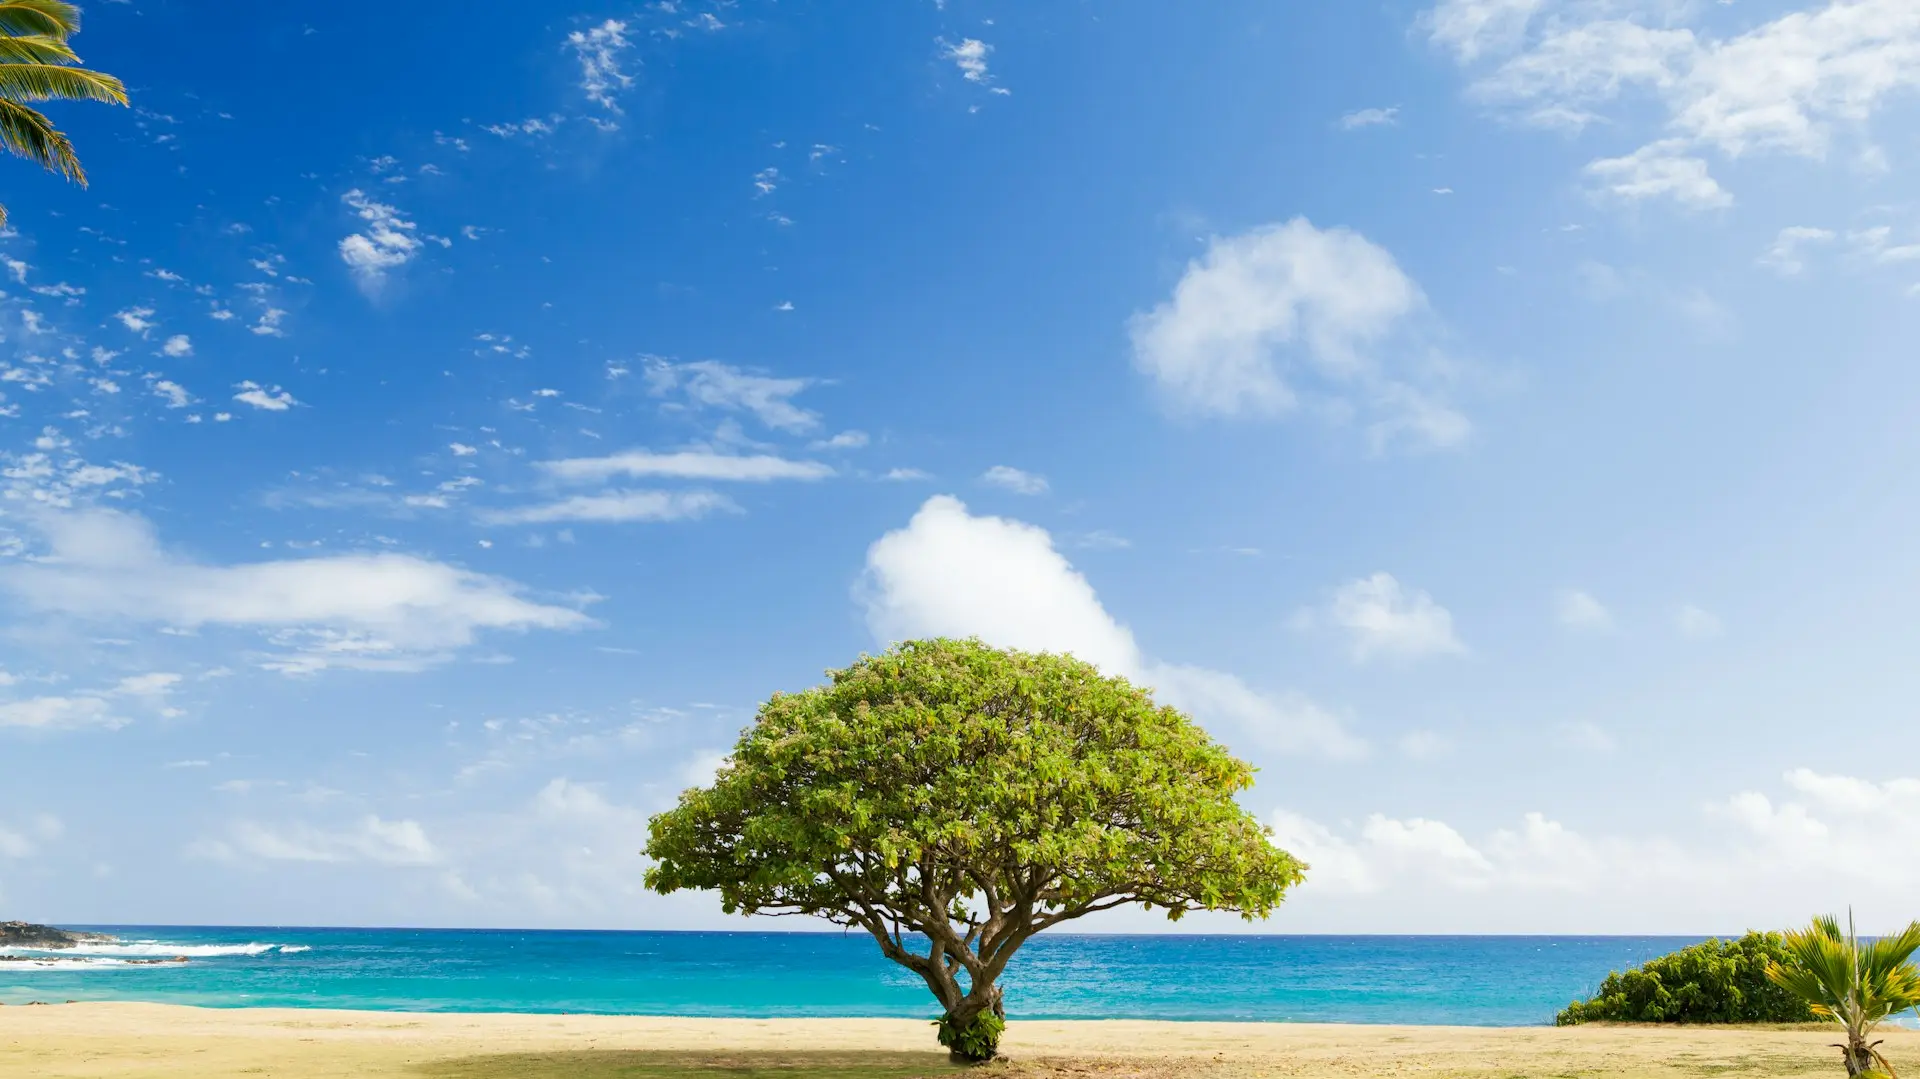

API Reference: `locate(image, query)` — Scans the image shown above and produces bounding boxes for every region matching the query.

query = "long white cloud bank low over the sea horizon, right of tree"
[1269,768,1920,933]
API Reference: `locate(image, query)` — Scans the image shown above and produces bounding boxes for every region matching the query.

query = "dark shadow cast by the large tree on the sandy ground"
[417,1048,968,1079]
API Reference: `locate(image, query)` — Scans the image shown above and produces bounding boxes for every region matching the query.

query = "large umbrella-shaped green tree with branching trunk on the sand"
[645,639,1306,1062]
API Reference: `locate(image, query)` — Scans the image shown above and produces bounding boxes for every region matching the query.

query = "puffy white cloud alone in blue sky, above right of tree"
[1129,219,1471,447]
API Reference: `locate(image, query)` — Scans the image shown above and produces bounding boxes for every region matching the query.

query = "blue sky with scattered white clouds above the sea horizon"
[0,0,1920,933]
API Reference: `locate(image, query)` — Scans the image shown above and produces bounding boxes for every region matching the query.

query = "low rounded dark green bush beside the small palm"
[1553,933,1814,1027]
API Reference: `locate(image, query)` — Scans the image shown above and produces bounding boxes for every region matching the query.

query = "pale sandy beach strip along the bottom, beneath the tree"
[0,1004,1920,1079]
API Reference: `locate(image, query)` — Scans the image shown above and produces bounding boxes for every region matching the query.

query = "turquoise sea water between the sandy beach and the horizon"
[0,925,1697,1025]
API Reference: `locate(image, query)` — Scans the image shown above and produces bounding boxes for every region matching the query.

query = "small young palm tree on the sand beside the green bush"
[1766,914,1920,1077]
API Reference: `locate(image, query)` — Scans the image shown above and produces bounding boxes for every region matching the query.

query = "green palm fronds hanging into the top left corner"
[0,0,127,225]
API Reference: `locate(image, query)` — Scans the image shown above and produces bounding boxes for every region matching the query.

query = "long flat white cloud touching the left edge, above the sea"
[0,509,589,672]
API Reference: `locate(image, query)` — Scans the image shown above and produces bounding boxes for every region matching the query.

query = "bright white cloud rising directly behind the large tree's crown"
[856,495,1365,756]
